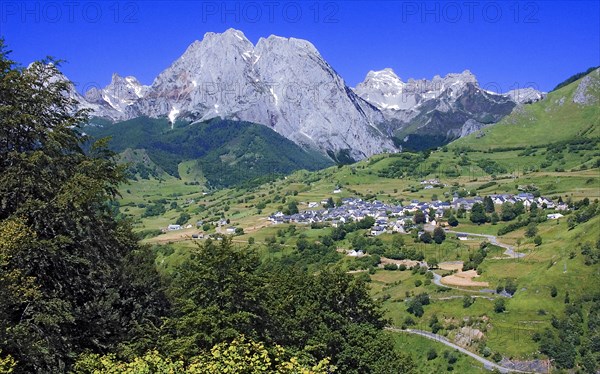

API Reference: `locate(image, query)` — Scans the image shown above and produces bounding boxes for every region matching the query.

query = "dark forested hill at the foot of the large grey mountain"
[84,117,332,188]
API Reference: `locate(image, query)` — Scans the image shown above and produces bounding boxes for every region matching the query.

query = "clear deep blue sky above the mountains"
[0,0,600,92]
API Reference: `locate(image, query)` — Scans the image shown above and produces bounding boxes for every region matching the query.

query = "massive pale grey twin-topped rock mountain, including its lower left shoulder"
[86,29,396,159]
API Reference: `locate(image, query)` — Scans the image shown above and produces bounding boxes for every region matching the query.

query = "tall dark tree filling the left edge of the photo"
[0,41,165,372]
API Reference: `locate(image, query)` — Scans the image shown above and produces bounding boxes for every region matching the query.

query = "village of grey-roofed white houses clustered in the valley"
[268,193,568,236]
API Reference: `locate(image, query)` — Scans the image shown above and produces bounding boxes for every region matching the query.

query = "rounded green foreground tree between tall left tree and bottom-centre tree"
[164,237,266,357]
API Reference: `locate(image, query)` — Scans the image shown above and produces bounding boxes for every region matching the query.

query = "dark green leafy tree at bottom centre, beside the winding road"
[264,267,414,374]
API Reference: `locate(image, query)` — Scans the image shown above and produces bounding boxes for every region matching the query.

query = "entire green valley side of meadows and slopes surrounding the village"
[85,68,600,373]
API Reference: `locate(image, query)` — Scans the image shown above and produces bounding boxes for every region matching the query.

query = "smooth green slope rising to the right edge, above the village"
[450,69,600,150]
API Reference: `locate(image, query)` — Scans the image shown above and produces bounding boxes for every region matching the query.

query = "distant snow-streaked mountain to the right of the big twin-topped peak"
[355,69,532,149]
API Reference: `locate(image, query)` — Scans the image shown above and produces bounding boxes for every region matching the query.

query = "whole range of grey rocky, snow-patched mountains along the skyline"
[73,29,545,160]
